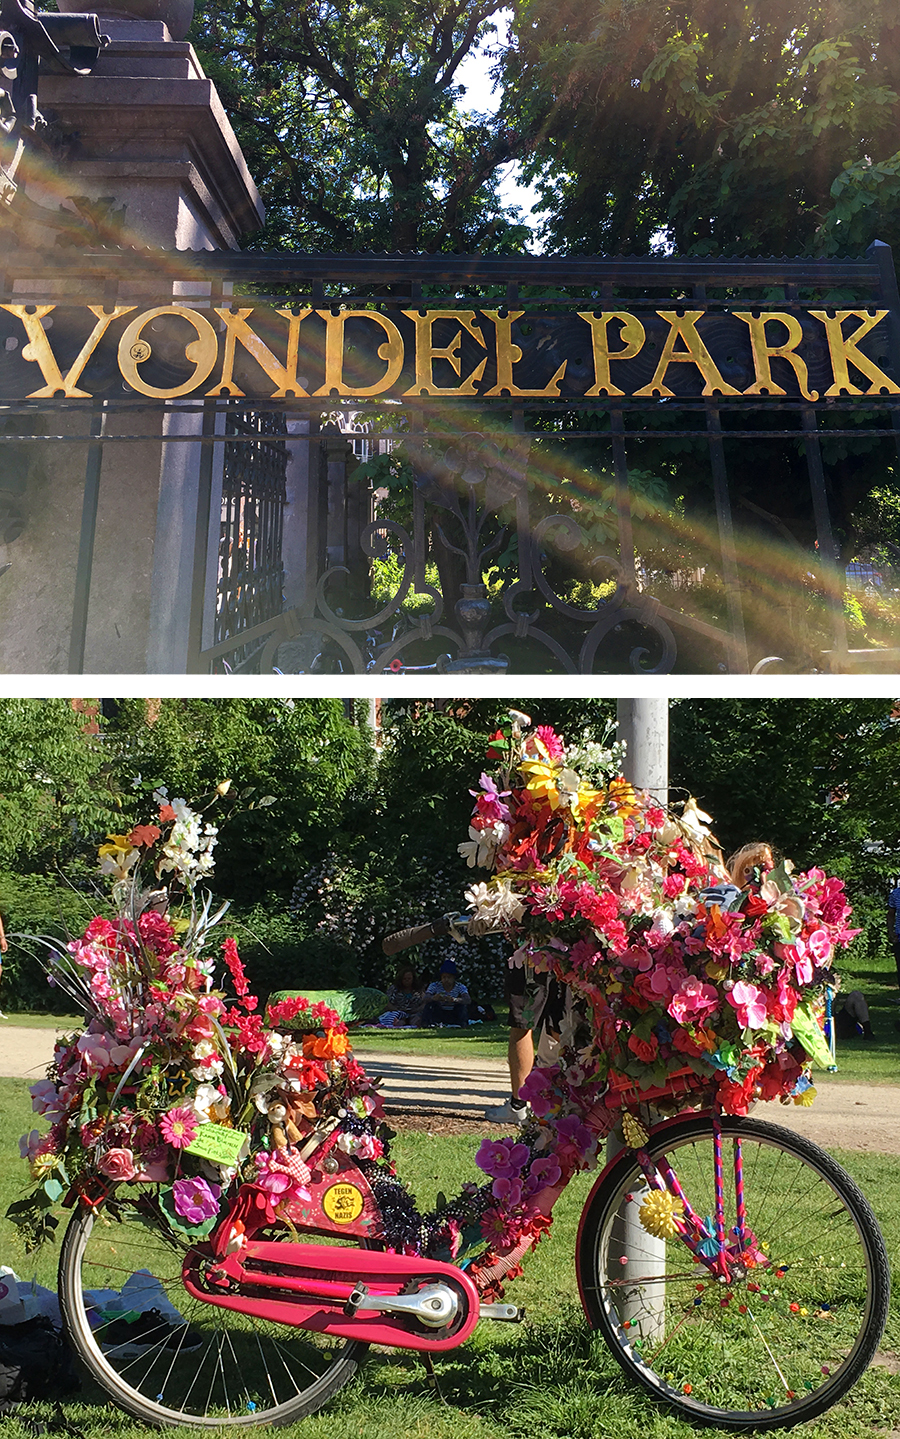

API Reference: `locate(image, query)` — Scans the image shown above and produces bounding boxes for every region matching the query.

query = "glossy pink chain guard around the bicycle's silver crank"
[181,1240,480,1353]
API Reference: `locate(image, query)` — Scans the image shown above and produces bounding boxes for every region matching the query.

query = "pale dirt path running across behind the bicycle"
[0,1023,900,1154]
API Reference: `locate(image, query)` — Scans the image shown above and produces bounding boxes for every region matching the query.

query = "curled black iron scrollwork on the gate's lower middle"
[266,433,677,673]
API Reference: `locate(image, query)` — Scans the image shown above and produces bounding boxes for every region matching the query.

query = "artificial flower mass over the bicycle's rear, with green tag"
[9,791,380,1245]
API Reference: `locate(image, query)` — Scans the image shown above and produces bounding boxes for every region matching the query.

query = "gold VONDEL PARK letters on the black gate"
[0,304,900,403]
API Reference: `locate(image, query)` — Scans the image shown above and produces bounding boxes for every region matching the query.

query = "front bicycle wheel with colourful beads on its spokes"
[576,1115,890,1430]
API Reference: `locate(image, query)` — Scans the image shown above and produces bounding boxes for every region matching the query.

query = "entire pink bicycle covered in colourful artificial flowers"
[13,736,888,1429]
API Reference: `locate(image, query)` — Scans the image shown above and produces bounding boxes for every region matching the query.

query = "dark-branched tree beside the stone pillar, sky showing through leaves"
[192,0,527,253]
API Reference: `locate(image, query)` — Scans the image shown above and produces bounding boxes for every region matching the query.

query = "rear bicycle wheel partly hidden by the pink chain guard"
[59,1207,369,1429]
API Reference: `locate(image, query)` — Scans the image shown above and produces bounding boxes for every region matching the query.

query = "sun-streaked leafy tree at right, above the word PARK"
[505,0,900,255]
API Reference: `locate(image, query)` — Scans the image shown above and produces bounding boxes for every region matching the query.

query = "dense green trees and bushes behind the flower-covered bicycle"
[0,696,900,1009]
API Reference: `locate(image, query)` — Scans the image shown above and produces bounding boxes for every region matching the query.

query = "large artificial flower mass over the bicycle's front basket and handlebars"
[459,717,858,1114]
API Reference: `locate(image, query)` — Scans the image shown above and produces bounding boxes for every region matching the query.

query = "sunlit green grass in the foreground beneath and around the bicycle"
[0,1079,900,1439]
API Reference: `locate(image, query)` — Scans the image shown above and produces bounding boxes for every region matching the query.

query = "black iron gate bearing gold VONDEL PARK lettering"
[0,245,900,673]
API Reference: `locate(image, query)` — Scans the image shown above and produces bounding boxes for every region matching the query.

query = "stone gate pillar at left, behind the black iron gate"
[0,11,264,673]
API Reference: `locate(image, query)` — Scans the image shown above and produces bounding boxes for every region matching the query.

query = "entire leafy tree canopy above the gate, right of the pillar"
[192,0,900,255]
